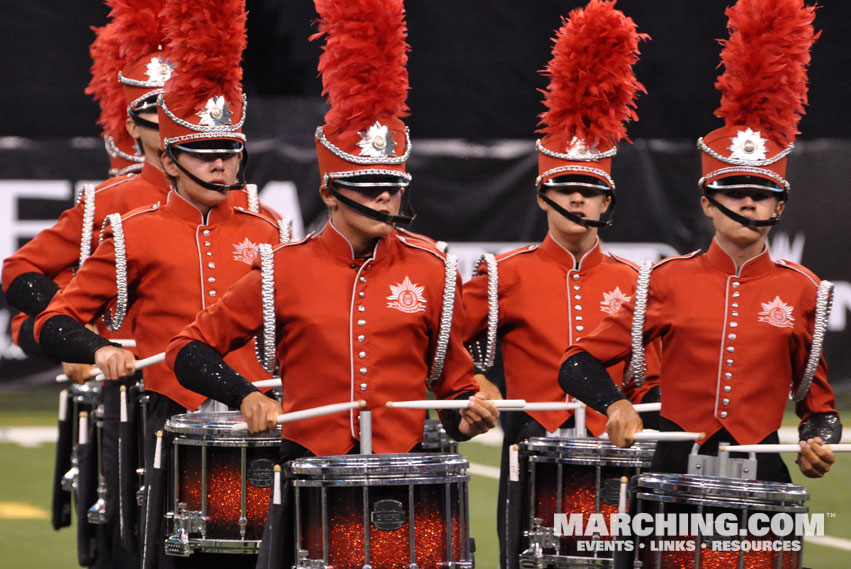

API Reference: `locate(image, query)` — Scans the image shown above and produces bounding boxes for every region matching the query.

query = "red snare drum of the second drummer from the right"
[515,437,656,567]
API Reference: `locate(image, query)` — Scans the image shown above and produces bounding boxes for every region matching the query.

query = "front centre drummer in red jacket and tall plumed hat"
[167,0,498,567]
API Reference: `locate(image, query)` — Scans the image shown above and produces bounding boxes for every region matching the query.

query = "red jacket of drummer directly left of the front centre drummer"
[35,192,280,410]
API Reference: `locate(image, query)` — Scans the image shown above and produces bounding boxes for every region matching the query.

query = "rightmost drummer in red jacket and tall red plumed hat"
[559,0,842,482]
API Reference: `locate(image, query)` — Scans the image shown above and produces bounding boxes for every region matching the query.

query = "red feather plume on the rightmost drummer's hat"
[715,0,821,146]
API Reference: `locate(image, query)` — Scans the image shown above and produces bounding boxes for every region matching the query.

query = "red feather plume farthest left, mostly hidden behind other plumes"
[86,22,130,140]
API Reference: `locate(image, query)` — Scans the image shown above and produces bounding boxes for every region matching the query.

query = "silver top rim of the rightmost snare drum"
[635,472,810,505]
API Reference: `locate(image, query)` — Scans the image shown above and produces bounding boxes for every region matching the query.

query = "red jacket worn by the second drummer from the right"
[464,234,659,435]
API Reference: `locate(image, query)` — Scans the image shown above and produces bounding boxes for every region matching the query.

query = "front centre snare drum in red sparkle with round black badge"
[286,454,474,569]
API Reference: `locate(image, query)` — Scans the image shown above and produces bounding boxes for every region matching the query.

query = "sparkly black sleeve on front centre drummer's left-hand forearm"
[174,340,260,409]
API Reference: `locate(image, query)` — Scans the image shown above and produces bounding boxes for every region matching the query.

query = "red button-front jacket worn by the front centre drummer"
[167,223,478,456]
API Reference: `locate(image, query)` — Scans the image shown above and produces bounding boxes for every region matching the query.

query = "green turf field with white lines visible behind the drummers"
[0,388,851,569]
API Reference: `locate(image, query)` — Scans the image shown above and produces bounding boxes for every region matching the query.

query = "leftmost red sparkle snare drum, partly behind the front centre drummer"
[160,411,281,556]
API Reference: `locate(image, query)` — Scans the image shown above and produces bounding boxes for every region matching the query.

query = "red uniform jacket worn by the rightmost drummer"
[565,240,835,444]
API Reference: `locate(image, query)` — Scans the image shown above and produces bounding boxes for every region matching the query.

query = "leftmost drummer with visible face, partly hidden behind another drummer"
[2,0,279,364]
